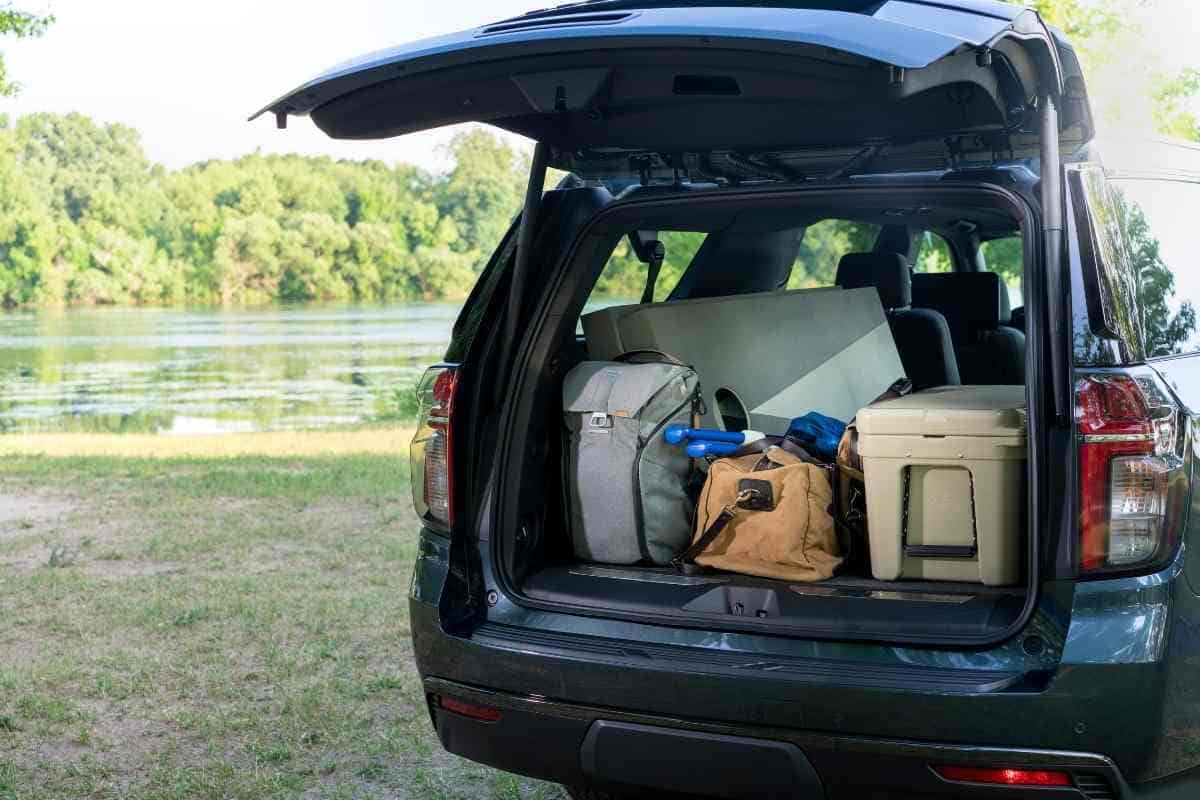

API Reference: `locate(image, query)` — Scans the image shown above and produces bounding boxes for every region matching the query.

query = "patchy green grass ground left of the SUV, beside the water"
[0,431,560,800]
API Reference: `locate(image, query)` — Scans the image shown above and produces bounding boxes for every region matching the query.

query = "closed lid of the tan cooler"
[856,386,1027,437]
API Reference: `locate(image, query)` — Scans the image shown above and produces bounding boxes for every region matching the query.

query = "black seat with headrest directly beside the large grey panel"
[838,252,961,390]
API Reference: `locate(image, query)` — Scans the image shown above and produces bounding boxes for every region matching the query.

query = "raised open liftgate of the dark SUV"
[259,0,1090,170]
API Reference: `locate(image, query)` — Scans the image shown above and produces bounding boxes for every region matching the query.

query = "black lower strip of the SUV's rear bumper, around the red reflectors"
[425,678,1132,800]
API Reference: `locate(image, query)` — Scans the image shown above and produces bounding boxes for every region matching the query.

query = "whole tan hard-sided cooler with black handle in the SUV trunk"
[857,386,1027,587]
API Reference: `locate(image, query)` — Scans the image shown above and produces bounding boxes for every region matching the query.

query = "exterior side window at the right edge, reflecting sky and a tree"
[1110,180,1200,357]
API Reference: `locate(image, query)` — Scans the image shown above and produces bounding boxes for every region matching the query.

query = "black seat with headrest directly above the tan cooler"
[912,272,1025,385]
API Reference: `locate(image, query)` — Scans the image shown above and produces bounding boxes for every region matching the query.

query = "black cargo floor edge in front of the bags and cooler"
[522,565,1025,639]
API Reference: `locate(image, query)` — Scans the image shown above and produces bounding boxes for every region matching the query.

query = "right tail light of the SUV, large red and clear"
[1075,373,1182,572]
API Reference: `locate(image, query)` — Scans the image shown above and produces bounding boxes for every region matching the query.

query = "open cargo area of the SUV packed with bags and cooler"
[502,181,1032,642]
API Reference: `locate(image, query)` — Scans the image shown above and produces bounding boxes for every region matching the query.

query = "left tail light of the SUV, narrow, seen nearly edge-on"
[409,365,458,529]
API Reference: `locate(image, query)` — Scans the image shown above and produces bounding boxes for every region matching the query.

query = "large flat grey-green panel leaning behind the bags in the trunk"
[583,288,905,434]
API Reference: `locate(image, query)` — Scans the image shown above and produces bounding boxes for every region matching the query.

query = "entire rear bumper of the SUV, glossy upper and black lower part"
[410,585,1200,800]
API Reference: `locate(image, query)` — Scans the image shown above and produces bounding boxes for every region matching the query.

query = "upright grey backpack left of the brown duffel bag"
[563,354,702,564]
